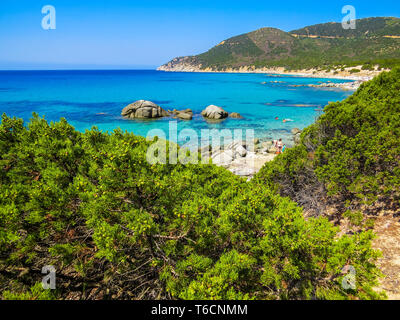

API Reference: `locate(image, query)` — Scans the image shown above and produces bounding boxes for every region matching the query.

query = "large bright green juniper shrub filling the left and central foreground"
[0,112,383,299]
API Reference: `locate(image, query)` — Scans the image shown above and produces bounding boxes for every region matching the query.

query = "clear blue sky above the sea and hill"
[0,0,400,69]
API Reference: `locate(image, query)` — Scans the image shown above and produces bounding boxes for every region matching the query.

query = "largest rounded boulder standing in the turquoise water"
[121,100,168,119]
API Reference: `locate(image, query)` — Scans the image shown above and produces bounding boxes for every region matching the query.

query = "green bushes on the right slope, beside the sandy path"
[258,68,400,215]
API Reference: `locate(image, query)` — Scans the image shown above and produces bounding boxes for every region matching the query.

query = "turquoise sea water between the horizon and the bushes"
[0,70,351,142]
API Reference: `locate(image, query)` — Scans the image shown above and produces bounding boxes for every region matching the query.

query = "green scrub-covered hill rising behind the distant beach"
[160,18,400,71]
